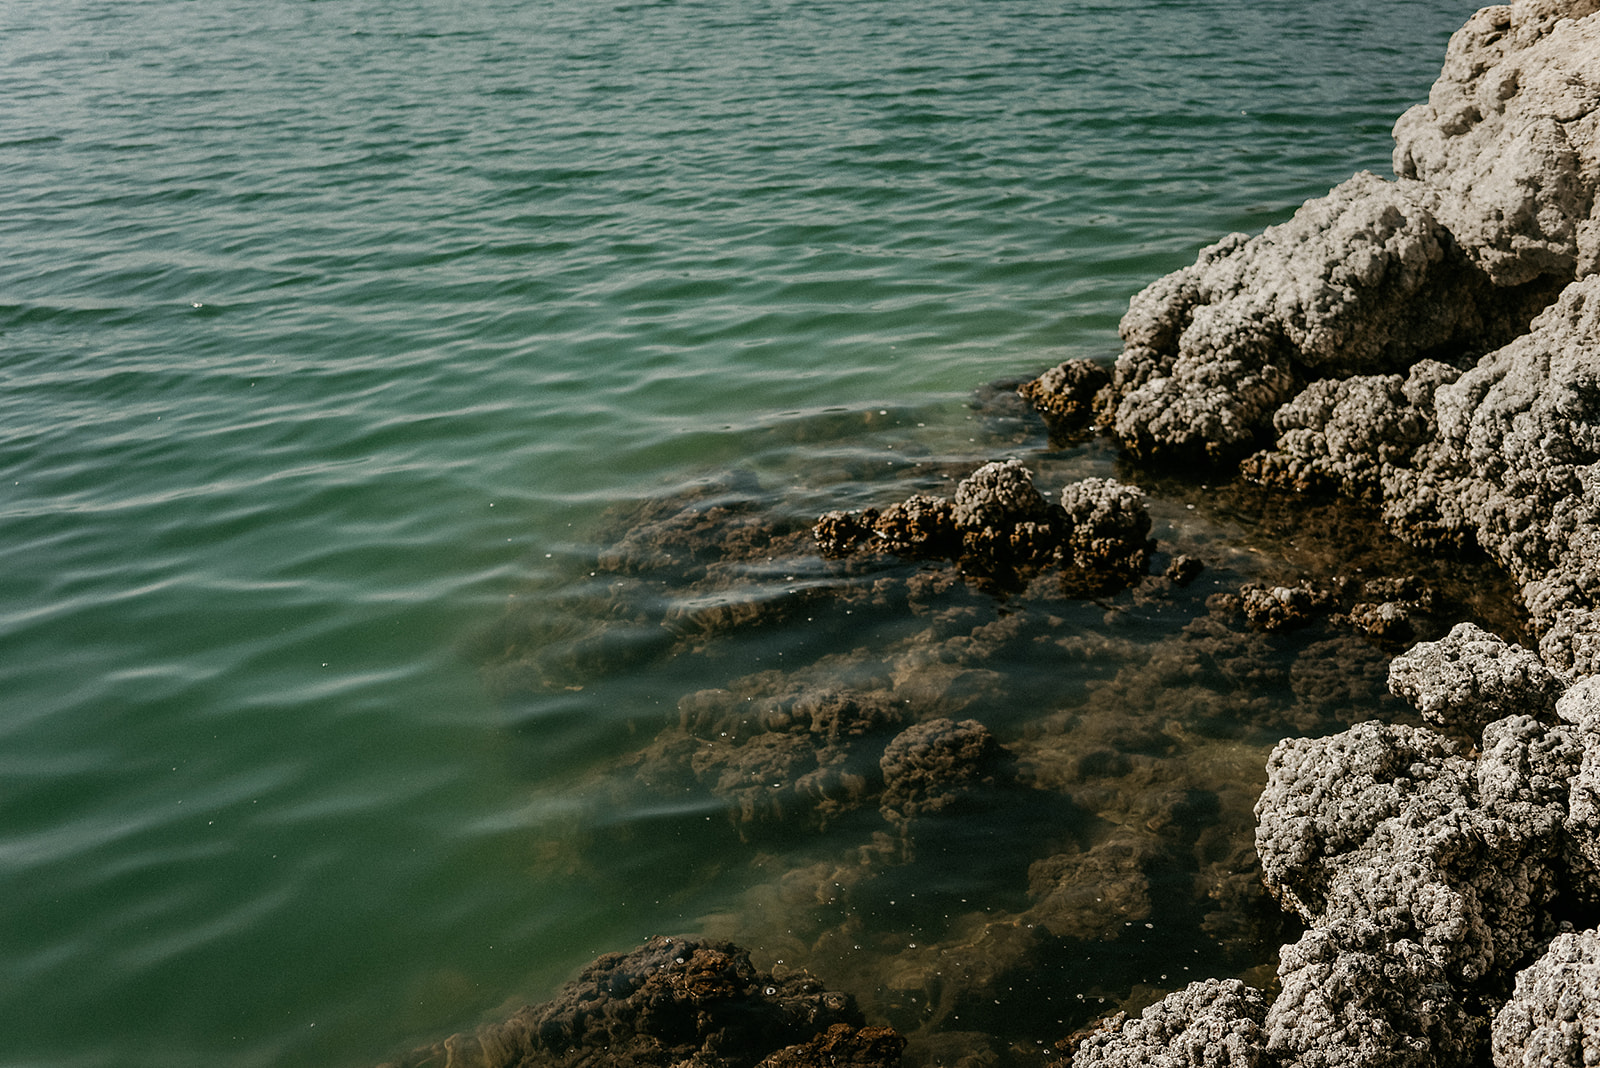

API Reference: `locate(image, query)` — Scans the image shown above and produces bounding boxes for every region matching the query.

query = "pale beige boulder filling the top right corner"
[1394,0,1600,286]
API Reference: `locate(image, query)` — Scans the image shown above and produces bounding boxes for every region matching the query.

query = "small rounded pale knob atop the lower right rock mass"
[1389,624,1563,737]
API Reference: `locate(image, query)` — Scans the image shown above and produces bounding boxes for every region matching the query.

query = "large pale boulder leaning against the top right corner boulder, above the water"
[1104,173,1547,460]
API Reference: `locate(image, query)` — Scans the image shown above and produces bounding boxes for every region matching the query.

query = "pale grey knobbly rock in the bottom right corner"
[1493,931,1600,1068]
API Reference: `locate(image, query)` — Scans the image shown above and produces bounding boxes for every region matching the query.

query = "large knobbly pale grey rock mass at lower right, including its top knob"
[1256,613,1600,1068]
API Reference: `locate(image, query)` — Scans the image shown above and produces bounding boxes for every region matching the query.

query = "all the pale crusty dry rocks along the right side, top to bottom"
[1043,0,1600,1068]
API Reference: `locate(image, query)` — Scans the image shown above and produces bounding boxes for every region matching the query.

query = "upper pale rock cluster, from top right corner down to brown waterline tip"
[1024,0,1600,675]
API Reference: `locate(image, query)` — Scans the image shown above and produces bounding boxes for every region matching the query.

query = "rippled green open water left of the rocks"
[0,0,1474,1068]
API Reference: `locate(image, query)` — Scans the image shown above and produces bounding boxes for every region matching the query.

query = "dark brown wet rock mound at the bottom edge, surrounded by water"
[377,937,904,1068]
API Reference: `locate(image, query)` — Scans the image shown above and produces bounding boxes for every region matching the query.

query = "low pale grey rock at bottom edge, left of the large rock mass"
[1072,978,1272,1068]
